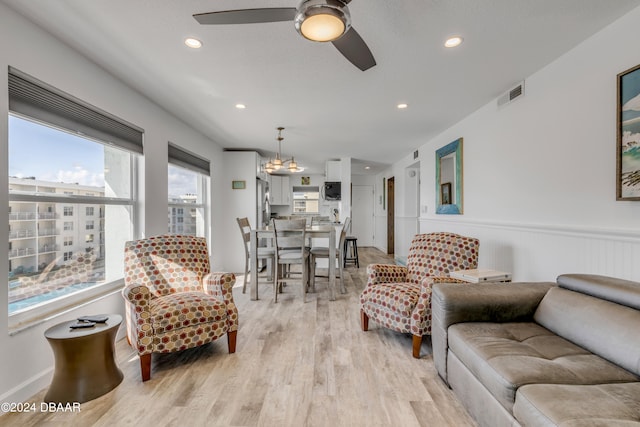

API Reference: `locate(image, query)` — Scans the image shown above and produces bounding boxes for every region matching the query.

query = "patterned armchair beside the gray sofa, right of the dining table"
[360,233,480,358]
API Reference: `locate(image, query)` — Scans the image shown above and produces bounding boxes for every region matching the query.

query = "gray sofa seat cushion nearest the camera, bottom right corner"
[513,382,640,427]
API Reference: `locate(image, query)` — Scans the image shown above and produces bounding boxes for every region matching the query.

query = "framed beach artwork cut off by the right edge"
[616,65,640,200]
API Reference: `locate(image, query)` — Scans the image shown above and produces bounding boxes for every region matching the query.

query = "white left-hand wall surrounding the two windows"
[0,3,224,402]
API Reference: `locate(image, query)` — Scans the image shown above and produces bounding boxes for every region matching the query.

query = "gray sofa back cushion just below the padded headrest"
[533,287,640,375]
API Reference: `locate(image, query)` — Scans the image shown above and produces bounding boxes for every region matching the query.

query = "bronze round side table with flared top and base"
[44,314,123,403]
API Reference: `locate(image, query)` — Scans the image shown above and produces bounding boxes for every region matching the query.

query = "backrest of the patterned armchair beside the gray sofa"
[407,232,480,284]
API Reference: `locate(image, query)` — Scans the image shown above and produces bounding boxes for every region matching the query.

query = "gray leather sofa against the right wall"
[431,274,640,427]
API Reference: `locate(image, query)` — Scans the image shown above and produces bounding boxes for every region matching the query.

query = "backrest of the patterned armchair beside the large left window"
[124,234,211,297]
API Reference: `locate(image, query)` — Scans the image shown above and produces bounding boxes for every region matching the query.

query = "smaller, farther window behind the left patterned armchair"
[167,143,210,237]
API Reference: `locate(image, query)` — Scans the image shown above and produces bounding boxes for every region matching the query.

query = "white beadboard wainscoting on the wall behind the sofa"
[420,218,640,281]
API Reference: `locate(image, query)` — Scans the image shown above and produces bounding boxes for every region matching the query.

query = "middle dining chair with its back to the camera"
[273,219,309,302]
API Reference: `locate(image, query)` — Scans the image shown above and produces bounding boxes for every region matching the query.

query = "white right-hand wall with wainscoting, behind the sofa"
[392,4,640,280]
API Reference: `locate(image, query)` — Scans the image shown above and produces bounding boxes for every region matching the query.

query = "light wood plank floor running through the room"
[0,248,475,427]
